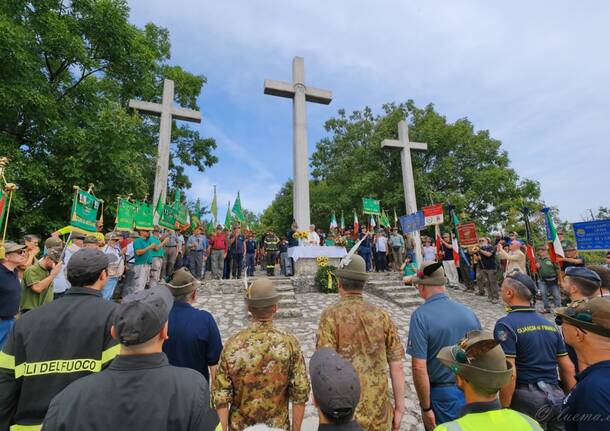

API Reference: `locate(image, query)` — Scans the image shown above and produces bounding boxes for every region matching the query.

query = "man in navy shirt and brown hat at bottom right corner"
[556,297,610,431]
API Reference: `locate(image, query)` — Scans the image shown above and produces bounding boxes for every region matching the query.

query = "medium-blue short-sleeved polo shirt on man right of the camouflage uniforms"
[407,293,481,385]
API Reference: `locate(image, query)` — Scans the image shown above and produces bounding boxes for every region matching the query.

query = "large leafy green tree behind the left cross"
[0,0,217,240]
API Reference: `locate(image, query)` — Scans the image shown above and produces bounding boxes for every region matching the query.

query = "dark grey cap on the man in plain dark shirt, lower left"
[114,286,174,346]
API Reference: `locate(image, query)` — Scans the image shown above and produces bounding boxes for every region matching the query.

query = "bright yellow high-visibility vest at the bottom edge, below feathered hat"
[434,409,542,431]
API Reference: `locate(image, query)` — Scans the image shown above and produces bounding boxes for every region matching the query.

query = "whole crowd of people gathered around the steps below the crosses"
[0,226,610,431]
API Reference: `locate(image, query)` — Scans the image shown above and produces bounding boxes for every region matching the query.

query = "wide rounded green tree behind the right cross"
[263,101,540,235]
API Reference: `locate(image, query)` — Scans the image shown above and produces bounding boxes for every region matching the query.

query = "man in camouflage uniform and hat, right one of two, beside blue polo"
[316,252,405,431]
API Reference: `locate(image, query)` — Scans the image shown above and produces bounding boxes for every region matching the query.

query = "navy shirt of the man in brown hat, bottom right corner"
[561,361,610,431]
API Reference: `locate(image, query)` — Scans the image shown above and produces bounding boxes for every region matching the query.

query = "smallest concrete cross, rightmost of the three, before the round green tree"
[381,120,428,266]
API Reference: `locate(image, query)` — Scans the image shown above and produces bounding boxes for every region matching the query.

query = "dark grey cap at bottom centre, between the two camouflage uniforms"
[309,347,360,419]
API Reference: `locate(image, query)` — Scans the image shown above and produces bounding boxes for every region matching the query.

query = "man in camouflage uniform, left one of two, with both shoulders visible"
[212,278,309,431]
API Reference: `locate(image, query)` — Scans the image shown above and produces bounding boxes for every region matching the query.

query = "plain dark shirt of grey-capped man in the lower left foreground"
[43,353,218,431]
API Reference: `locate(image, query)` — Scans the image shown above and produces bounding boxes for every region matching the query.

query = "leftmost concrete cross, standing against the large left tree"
[129,79,201,209]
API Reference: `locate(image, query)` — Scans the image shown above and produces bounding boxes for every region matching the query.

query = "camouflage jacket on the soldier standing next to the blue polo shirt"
[316,295,405,431]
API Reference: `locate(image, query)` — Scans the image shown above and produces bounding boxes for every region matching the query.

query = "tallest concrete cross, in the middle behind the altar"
[265,57,333,230]
